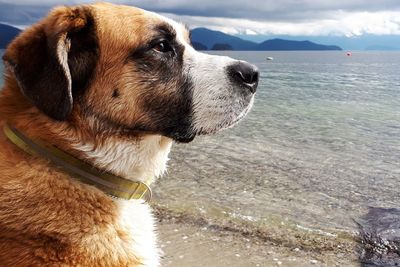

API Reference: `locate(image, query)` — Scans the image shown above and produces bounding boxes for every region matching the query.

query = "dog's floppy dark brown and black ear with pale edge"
[3,7,97,120]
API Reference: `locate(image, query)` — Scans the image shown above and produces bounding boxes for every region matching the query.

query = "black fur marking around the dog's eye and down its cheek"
[126,25,194,142]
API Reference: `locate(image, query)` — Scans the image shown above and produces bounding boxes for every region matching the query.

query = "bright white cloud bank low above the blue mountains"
[164,11,400,37]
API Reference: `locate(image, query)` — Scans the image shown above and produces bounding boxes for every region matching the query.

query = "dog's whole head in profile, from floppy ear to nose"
[4,4,259,141]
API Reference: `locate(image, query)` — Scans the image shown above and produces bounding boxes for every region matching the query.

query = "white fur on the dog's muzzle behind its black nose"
[185,49,253,134]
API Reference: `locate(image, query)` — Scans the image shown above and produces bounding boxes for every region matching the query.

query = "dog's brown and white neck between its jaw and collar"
[6,123,172,185]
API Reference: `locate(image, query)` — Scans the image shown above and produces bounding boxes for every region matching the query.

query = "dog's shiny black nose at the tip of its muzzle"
[228,61,260,94]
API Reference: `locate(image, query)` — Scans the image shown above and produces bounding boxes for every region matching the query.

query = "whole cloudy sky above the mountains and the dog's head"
[0,0,400,37]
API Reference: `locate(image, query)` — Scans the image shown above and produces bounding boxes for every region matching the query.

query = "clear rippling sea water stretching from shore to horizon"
[0,51,400,264]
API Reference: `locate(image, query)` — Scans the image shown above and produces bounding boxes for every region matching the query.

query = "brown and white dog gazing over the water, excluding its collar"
[0,3,258,266]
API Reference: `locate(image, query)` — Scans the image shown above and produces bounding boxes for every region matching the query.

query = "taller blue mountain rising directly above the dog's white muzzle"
[191,28,257,50]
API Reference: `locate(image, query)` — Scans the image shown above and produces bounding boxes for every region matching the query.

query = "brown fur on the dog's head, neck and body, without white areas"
[0,4,192,266]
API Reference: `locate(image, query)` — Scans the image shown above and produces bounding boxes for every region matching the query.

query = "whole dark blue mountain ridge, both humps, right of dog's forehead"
[191,28,342,51]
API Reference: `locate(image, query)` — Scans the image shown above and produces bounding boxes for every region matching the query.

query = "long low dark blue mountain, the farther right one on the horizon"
[257,39,342,51]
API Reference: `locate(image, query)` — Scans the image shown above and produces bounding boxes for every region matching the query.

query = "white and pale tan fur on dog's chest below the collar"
[79,199,161,267]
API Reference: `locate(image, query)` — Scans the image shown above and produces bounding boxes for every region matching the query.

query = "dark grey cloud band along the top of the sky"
[0,0,400,22]
